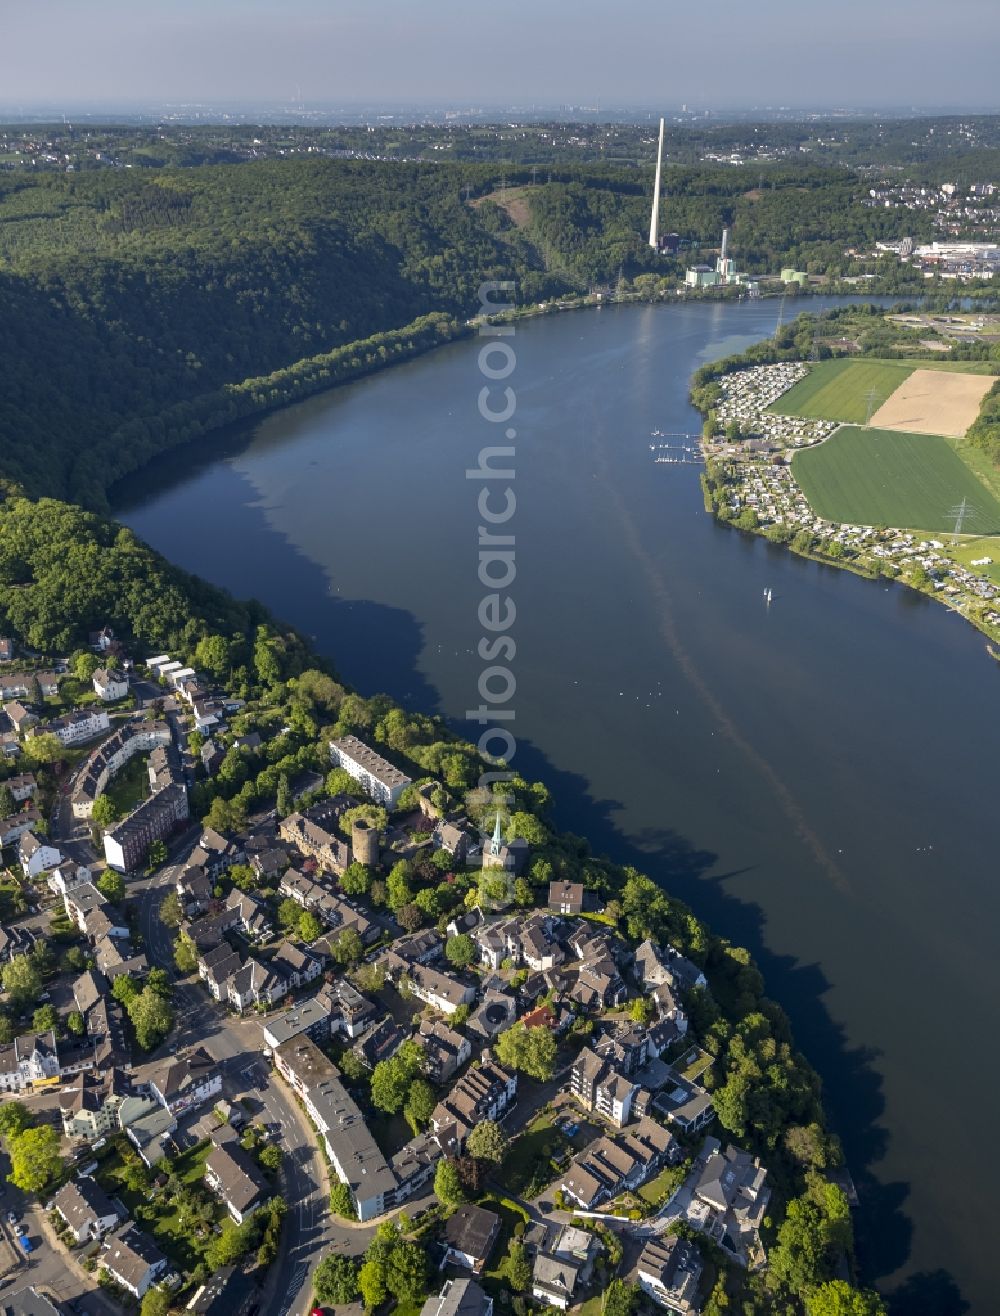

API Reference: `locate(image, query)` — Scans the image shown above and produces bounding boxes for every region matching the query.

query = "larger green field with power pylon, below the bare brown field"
[792,425,1000,534]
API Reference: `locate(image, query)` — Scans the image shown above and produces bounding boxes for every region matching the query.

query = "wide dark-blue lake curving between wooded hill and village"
[118,301,1000,1316]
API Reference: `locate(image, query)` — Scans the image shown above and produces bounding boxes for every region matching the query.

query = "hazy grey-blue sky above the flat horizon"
[0,0,1000,109]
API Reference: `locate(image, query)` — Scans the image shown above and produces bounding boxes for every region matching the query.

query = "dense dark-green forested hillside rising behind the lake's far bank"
[0,158,926,508]
